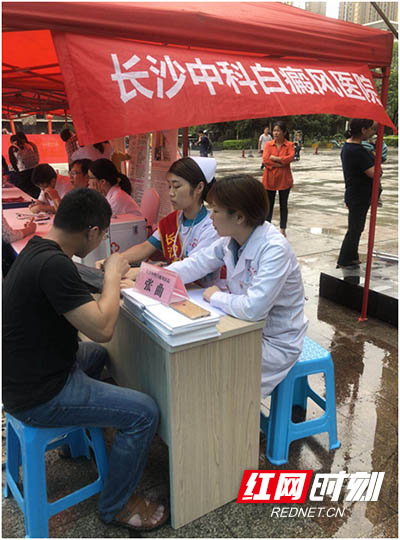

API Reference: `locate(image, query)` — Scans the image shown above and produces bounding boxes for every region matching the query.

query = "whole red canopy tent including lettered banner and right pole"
[2,2,393,317]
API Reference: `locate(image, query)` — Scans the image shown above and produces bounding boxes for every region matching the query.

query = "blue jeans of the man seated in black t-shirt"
[13,342,159,523]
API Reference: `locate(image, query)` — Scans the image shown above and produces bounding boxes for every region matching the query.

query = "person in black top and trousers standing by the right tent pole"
[337,118,378,267]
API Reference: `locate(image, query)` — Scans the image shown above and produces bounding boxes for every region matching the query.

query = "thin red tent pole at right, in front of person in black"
[358,67,390,322]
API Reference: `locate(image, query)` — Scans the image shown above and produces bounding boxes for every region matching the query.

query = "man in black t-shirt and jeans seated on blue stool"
[3,188,167,530]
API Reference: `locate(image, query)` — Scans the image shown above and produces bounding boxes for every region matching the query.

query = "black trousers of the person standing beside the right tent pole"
[338,202,369,266]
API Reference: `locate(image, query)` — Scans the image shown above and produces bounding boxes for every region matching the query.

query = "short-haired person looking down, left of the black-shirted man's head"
[29,163,72,214]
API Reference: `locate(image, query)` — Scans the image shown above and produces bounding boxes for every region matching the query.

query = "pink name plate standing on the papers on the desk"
[135,263,189,305]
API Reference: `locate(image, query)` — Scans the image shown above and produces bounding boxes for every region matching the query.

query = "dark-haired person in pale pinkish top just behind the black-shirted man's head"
[89,158,143,217]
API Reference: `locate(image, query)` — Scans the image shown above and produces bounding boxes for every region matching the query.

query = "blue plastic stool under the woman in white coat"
[260,337,340,465]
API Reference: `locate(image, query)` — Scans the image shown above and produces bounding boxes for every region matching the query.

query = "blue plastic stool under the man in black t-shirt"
[3,414,108,538]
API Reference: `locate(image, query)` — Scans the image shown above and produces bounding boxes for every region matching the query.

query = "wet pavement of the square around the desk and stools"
[2,149,398,538]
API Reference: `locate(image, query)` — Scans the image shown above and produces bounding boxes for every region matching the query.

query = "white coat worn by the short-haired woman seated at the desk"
[168,222,308,397]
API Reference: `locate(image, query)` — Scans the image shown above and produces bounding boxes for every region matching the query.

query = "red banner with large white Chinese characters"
[53,32,393,144]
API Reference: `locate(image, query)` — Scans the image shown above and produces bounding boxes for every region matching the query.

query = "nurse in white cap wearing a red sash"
[97,156,218,281]
